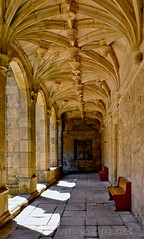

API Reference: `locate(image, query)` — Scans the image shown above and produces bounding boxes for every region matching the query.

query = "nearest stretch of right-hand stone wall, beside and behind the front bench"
[118,66,144,225]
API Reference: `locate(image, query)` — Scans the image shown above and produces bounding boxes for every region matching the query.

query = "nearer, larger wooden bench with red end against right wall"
[108,177,131,211]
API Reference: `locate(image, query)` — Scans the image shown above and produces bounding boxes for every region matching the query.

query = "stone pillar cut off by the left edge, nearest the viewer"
[0,58,8,223]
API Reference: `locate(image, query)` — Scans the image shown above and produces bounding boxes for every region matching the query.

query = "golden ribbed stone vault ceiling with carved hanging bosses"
[0,0,143,122]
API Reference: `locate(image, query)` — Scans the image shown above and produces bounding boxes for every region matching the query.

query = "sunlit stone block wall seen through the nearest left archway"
[6,67,21,194]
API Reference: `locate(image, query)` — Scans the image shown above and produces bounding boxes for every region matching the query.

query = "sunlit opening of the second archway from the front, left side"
[36,91,50,182]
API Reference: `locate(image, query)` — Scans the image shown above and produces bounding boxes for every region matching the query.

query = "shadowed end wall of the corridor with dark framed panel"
[63,118,102,173]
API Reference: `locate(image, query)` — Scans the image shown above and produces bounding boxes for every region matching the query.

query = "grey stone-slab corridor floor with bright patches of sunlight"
[0,173,144,239]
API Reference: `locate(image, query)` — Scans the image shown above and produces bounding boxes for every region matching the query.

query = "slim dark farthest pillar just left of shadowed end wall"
[57,119,63,166]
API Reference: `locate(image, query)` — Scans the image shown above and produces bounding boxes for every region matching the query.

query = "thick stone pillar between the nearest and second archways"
[19,91,37,194]
